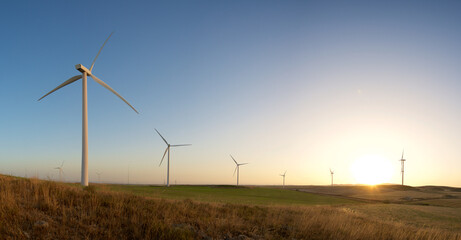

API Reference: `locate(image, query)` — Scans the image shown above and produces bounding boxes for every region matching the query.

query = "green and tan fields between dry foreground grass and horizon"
[99,185,461,231]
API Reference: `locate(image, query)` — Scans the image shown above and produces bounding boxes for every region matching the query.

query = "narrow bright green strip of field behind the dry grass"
[99,185,357,205]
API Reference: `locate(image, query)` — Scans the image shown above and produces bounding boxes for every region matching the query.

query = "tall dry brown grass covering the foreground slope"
[0,176,461,240]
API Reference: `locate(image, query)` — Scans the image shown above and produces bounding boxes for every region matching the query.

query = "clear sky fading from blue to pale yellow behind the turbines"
[0,0,461,187]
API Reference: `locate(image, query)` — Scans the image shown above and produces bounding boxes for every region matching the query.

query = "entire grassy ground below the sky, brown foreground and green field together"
[0,175,461,239]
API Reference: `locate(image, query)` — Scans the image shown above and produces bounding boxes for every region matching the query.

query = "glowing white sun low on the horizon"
[351,155,393,185]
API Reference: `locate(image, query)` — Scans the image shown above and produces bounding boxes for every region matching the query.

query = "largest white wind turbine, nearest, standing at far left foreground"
[38,33,138,186]
